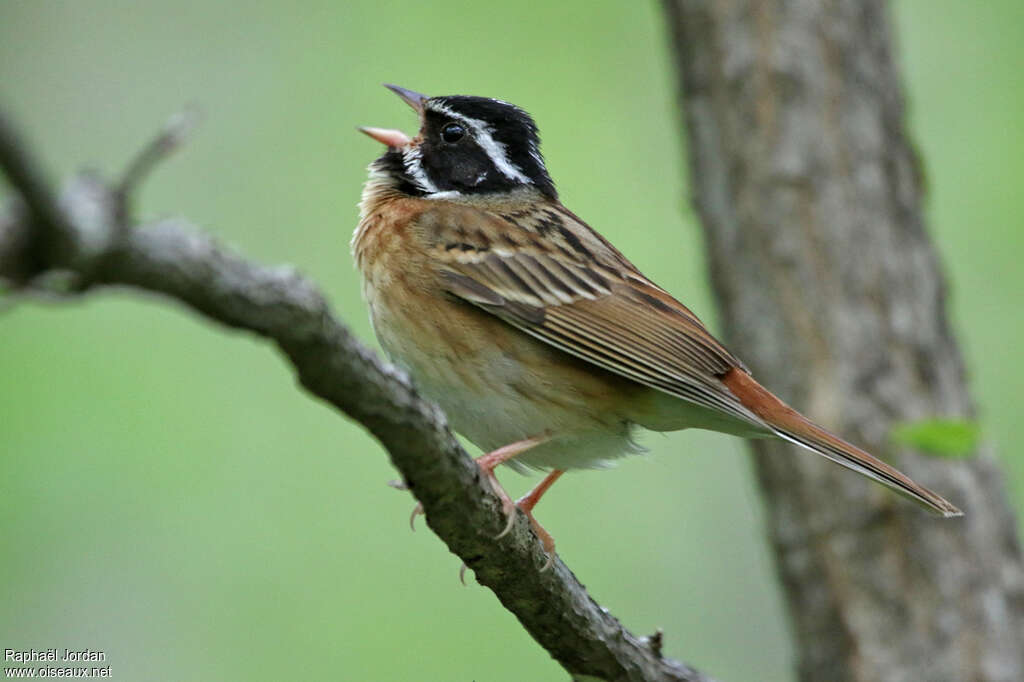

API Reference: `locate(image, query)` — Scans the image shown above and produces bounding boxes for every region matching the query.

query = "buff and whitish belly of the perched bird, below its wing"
[366,280,648,469]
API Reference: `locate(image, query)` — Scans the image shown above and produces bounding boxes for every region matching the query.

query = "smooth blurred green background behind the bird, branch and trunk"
[0,0,1024,682]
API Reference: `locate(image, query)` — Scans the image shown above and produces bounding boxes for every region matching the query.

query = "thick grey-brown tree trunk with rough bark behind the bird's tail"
[665,0,1024,682]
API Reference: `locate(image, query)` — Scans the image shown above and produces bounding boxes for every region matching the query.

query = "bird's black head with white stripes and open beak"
[359,85,557,200]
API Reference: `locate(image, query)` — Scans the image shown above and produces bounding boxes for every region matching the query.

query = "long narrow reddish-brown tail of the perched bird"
[721,368,963,517]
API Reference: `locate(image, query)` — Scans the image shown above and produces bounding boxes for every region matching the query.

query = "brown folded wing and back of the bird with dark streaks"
[434,199,764,426]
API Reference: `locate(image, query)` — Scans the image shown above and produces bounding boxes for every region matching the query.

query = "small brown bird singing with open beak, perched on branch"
[352,85,961,565]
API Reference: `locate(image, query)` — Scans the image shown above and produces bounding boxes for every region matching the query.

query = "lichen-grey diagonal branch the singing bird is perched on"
[0,109,710,682]
